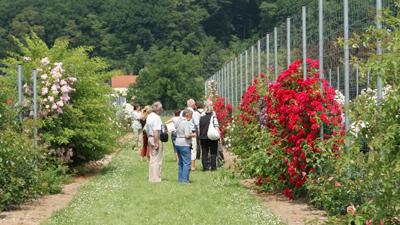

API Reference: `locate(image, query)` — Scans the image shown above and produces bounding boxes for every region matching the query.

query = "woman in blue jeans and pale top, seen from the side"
[175,109,196,183]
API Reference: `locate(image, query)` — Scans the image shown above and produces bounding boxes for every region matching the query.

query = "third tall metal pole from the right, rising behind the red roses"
[319,0,324,140]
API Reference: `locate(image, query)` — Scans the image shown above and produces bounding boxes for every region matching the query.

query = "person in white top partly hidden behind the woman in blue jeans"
[181,99,200,171]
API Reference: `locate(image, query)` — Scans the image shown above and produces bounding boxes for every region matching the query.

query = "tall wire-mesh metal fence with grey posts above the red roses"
[205,0,394,134]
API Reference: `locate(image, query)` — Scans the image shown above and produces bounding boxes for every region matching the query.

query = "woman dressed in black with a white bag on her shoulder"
[199,101,219,171]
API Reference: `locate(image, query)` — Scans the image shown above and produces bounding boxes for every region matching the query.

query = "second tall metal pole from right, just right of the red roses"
[344,0,350,141]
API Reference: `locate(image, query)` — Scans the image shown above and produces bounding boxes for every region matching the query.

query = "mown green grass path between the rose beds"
[44,140,282,225]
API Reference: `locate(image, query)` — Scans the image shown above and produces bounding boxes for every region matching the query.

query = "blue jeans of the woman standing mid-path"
[175,145,191,183]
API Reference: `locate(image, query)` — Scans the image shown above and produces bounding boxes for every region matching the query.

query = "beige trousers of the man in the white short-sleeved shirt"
[149,137,163,182]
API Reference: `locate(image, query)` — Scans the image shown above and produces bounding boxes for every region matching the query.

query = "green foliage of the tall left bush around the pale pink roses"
[2,34,118,160]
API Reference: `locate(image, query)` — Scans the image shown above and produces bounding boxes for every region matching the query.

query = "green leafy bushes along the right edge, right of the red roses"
[307,1,400,224]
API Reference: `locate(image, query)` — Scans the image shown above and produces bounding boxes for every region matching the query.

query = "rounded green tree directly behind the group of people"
[128,48,204,109]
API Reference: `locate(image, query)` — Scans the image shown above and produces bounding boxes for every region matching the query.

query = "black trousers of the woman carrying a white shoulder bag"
[200,139,218,171]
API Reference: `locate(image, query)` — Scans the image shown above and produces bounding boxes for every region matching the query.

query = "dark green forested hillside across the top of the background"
[0,0,310,107]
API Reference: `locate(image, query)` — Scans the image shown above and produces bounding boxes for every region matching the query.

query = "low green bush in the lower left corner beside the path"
[0,129,67,211]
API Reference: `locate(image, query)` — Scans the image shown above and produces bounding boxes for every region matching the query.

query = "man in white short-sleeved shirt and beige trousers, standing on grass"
[146,102,163,182]
